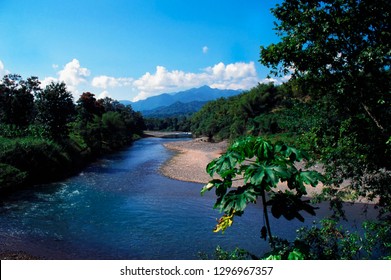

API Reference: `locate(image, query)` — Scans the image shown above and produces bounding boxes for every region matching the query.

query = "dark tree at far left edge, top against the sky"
[0,74,40,128]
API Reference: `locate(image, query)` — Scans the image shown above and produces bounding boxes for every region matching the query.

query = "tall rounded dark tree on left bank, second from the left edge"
[36,82,76,140]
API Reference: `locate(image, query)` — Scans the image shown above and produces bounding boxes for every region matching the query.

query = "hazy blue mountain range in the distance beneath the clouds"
[120,86,242,117]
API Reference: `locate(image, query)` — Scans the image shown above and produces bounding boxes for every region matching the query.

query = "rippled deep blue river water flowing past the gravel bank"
[0,138,380,260]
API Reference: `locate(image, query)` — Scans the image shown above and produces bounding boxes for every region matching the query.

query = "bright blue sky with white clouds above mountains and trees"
[0,0,281,101]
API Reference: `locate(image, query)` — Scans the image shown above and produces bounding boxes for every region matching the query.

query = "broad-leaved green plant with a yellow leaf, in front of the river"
[201,136,323,245]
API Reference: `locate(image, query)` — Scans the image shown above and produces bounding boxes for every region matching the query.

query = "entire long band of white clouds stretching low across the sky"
[36,59,289,101]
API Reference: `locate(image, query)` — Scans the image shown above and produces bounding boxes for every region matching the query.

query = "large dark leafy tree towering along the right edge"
[260,0,391,212]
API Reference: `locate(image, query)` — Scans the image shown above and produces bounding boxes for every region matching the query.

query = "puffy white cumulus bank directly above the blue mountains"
[133,62,259,101]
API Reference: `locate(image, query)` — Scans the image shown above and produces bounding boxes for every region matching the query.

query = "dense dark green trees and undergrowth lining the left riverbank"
[0,75,144,191]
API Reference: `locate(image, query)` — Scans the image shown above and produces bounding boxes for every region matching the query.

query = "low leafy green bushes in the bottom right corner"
[264,219,391,260]
